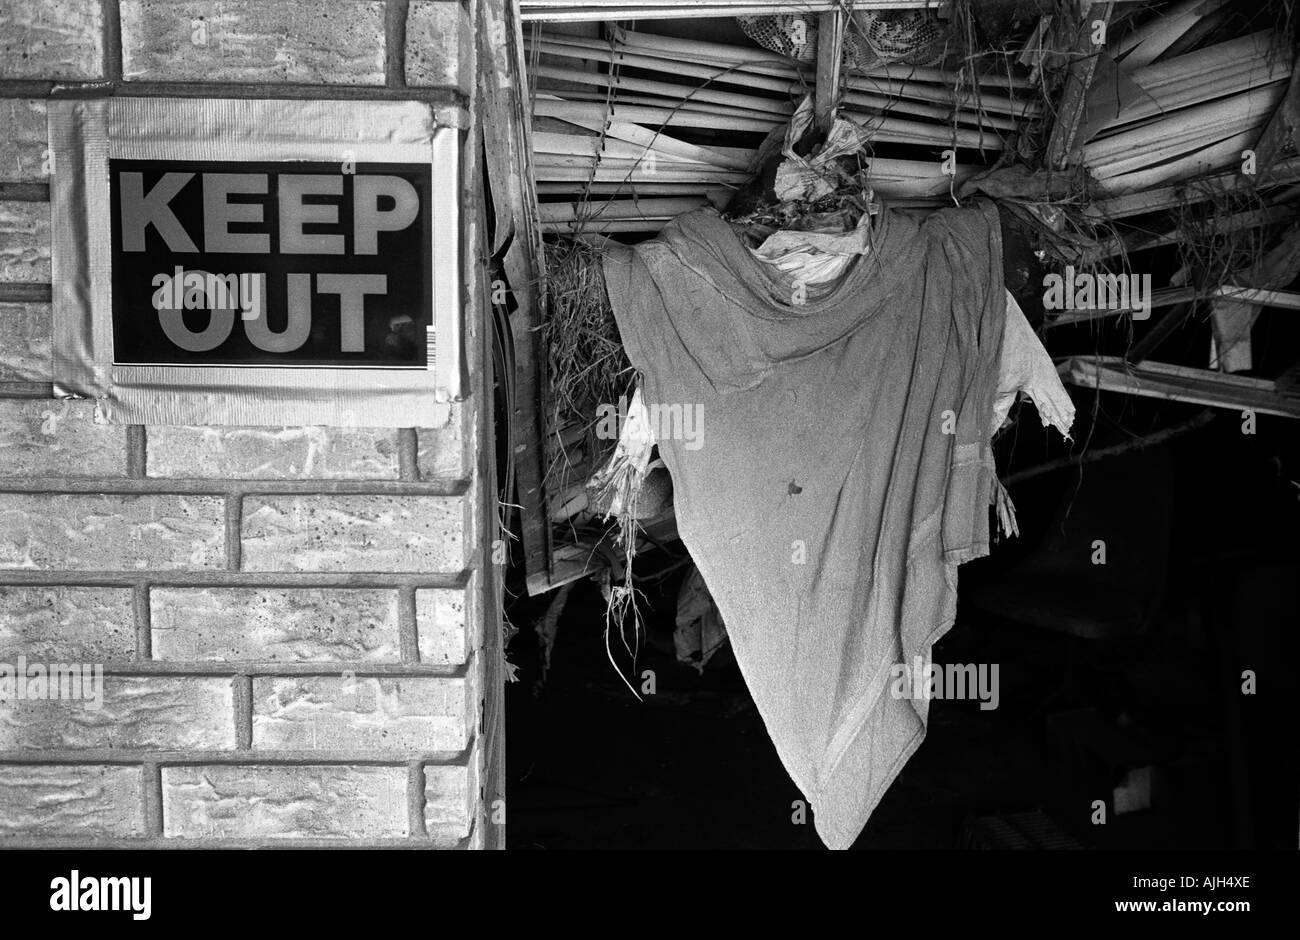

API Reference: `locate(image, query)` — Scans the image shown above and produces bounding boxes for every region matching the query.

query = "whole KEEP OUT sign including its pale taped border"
[48,98,464,426]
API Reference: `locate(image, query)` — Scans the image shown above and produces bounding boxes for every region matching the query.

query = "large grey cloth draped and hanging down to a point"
[603,204,1006,848]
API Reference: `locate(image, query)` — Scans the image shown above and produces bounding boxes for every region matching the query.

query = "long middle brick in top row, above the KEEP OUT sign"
[122,0,385,85]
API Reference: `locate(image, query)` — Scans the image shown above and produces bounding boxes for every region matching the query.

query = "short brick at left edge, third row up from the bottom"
[0,586,135,664]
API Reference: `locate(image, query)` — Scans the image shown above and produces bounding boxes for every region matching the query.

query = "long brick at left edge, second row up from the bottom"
[0,676,235,750]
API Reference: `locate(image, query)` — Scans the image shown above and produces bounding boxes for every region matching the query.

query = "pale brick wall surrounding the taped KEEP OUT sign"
[0,0,503,846]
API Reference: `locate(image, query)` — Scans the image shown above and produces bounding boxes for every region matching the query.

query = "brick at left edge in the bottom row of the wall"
[0,764,144,845]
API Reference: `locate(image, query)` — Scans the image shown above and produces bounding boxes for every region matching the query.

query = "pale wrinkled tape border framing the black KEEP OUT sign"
[48,98,464,428]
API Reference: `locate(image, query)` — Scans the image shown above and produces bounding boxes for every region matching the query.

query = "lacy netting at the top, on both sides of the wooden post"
[736,10,949,70]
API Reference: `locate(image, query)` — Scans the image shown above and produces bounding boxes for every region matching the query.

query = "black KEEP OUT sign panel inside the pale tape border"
[109,160,433,368]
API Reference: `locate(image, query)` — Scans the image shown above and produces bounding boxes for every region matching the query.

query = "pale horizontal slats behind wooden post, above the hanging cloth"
[527,25,1043,234]
